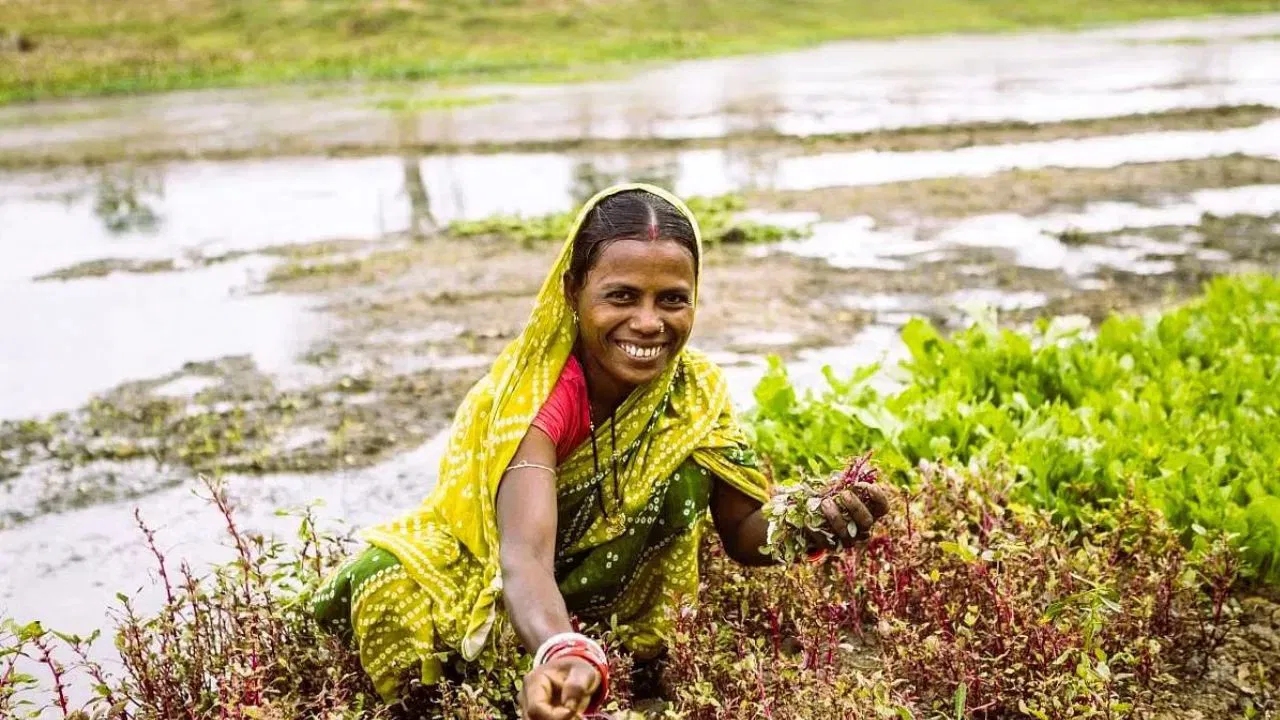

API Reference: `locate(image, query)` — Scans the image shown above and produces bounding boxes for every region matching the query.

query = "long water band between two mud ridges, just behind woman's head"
[0,115,1280,278]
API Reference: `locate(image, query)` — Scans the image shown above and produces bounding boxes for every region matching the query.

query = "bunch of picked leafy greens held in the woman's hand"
[764,452,879,564]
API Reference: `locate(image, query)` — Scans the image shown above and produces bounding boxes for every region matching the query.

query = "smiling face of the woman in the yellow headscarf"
[568,238,695,391]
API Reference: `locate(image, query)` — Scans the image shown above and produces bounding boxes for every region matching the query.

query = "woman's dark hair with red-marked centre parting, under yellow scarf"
[568,190,698,287]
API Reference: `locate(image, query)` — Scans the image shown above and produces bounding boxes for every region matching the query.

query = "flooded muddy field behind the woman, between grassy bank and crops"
[0,12,1280,712]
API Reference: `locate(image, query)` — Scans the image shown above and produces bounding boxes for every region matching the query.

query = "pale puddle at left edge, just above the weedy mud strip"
[0,258,323,419]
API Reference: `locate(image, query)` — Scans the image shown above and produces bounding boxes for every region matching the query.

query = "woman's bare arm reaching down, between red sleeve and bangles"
[497,428,572,652]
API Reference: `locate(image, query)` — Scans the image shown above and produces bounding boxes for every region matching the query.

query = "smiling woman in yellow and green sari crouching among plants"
[316,184,887,720]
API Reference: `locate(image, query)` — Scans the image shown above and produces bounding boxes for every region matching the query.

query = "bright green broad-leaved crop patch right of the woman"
[751,275,1280,582]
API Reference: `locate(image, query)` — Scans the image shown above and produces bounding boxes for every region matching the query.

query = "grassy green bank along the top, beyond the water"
[0,0,1280,102]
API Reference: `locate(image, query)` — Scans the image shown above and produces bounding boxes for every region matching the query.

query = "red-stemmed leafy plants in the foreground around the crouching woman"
[0,465,1235,720]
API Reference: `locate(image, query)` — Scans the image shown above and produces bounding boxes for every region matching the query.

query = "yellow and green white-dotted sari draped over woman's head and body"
[315,184,768,698]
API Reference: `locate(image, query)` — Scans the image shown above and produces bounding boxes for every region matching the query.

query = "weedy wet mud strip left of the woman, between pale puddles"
[0,357,477,528]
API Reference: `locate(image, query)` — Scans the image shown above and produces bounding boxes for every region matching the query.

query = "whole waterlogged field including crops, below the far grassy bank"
[0,11,1280,719]
